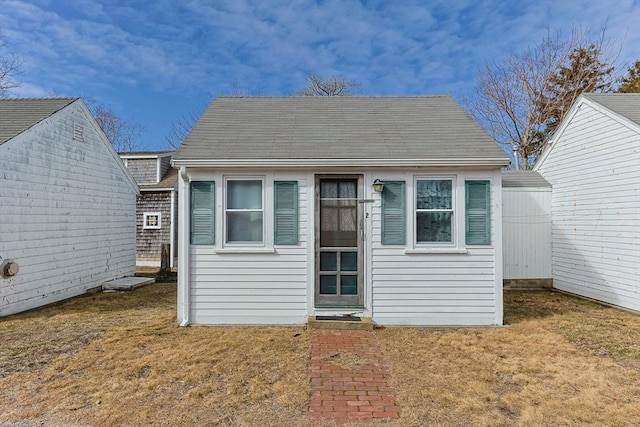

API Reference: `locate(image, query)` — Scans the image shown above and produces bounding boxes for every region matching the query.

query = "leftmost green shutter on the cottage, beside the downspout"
[191,181,216,245]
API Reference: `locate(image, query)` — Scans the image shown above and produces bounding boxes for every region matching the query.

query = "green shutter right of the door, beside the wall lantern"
[381,181,407,245]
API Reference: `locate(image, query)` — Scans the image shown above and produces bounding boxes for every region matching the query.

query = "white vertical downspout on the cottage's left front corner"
[178,166,191,326]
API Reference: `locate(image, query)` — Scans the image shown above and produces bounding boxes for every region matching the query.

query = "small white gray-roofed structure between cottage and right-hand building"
[502,171,553,288]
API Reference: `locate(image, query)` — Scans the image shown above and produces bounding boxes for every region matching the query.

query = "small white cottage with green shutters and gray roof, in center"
[173,96,509,325]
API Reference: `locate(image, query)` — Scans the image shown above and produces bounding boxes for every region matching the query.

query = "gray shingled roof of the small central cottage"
[174,96,508,164]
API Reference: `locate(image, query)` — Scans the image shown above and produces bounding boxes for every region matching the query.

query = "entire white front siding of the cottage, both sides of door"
[178,171,502,325]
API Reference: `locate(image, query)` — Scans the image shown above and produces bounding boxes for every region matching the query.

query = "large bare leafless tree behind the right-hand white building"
[467,33,613,170]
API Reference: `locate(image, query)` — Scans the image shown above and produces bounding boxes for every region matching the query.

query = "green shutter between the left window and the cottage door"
[273,181,298,245]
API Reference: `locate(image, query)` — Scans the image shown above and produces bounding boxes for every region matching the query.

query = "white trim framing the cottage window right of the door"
[404,173,467,254]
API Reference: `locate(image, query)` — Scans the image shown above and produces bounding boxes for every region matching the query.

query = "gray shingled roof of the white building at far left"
[0,98,79,144]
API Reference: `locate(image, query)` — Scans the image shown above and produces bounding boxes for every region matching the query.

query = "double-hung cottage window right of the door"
[415,178,455,245]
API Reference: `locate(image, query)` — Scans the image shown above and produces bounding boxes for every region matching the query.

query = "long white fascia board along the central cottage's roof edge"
[172,157,510,169]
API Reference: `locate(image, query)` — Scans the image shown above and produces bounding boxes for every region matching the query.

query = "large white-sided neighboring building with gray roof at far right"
[535,94,640,311]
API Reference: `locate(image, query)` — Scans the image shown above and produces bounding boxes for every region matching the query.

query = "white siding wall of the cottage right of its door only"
[371,172,502,325]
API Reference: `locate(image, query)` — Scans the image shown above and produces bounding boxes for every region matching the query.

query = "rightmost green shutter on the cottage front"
[465,181,491,245]
